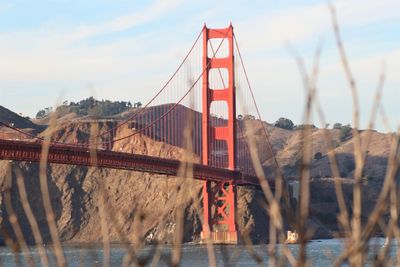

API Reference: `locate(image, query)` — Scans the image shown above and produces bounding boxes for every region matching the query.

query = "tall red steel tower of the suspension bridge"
[202,25,238,243]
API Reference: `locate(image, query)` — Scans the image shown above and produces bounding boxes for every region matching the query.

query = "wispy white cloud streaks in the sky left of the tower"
[0,0,188,82]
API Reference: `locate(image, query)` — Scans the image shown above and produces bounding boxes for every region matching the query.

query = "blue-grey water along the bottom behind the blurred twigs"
[0,238,397,267]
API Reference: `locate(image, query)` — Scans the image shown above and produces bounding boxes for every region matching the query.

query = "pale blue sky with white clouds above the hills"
[0,0,400,131]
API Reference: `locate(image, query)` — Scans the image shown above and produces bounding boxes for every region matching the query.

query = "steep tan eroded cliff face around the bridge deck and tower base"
[0,121,268,244]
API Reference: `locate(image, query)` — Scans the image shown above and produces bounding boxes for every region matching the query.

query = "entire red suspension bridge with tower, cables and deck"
[0,25,276,246]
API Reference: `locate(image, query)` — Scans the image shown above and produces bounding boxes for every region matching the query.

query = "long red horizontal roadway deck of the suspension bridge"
[0,139,273,185]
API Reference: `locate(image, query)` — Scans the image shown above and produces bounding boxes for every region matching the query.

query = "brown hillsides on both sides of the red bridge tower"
[0,104,390,243]
